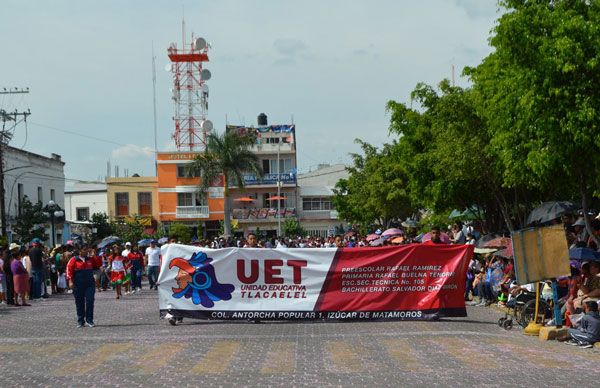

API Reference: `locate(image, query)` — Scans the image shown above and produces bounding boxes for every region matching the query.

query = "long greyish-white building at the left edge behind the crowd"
[3,146,65,243]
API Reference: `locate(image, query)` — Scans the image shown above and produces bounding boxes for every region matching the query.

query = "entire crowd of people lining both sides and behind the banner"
[0,219,600,347]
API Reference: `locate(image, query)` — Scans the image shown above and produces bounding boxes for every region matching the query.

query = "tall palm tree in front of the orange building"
[187,132,263,236]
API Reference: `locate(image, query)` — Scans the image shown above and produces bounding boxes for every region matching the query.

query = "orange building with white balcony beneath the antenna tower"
[156,151,224,237]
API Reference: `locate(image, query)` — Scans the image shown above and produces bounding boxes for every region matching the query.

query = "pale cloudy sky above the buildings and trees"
[0,0,499,185]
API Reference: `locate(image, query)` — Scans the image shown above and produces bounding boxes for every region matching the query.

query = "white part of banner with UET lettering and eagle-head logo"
[158,244,337,311]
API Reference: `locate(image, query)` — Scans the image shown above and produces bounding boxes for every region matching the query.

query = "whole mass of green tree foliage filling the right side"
[335,0,600,231]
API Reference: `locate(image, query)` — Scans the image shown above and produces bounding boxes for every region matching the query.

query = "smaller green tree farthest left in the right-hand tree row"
[333,139,412,227]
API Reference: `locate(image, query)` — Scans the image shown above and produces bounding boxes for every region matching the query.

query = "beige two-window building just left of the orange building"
[106,176,159,224]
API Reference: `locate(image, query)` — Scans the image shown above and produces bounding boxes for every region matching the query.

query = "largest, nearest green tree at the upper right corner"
[467,0,600,236]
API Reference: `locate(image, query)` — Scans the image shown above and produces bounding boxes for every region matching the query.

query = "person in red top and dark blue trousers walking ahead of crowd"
[66,247,102,327]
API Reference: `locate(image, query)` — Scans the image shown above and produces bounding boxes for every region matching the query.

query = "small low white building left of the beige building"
[65,182,108,222]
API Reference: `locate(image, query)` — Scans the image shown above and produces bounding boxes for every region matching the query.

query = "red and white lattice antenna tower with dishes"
[167,31,213,151]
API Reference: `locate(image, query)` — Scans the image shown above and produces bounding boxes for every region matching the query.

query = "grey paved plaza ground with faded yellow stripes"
[0,290,600,387]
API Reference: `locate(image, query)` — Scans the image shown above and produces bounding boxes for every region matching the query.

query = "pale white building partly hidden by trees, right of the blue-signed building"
[298,164,350,237]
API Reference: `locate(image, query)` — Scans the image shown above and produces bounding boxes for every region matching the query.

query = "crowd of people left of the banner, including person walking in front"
[0,239,160,327]
